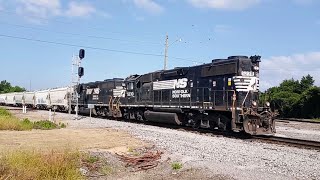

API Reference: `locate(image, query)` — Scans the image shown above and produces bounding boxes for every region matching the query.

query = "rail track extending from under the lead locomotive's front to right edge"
[252,136,320,150]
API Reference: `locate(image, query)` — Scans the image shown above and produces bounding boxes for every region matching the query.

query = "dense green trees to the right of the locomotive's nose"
[260,74,320,119]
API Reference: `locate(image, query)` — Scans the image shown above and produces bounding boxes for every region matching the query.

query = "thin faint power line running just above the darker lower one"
[0,22,162,45]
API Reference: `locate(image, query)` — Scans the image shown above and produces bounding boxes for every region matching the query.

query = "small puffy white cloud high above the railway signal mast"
[65,2,96,17]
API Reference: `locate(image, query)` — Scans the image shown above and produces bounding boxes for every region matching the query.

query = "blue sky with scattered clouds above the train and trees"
[0,0,320,90]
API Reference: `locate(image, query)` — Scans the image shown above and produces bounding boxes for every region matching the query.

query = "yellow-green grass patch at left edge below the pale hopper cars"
[0,108,66,131]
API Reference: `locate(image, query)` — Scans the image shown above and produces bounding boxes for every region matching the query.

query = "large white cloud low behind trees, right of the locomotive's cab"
[260,51,320,91]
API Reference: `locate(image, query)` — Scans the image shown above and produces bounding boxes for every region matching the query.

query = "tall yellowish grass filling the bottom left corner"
[0,151,84,180]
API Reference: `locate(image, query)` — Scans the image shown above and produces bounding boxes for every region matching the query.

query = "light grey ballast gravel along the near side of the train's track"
[63,117,320,179]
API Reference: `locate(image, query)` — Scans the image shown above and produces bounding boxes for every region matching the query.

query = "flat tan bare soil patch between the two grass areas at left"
[0,129,147,152]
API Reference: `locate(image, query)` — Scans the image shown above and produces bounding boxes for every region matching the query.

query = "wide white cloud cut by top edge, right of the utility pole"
[188,0,261,10]
